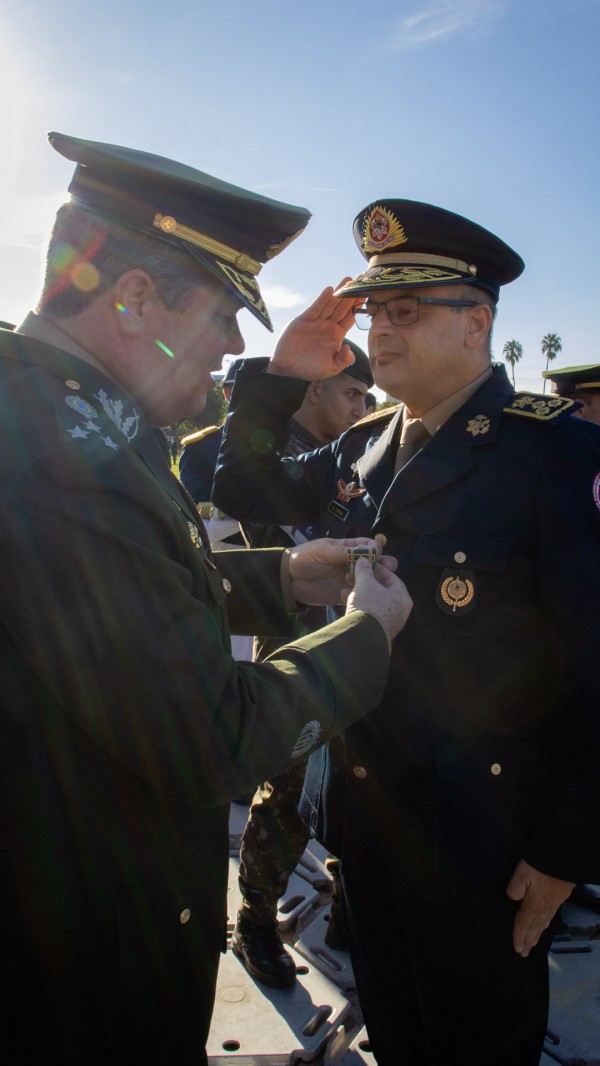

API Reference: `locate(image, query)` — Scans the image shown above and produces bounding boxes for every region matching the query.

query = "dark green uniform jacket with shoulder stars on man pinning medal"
[0,334,388,1066]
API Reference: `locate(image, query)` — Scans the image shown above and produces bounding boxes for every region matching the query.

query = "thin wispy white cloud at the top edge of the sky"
[383,0,502,53]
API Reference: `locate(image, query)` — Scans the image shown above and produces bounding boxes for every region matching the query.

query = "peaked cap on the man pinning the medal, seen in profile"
[48,132,310,330]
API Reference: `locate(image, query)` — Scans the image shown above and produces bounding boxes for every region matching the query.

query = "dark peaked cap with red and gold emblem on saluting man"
[336,199,524,300]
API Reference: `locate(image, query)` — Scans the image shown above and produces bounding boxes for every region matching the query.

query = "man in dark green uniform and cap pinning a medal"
[0,143,409,1066]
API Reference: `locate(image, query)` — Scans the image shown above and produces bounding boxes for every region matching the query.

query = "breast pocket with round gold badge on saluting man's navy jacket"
[413,533,515,636]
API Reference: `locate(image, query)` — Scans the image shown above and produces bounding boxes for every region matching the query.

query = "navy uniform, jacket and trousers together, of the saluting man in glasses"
[214,360,600,1066]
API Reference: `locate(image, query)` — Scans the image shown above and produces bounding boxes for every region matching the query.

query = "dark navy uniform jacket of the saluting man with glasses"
[213,360,600,887]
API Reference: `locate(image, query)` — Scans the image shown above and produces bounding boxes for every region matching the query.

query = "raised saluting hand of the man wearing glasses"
[266,278,361,382]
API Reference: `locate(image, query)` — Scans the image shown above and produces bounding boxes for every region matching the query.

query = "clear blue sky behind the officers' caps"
[0,0,600,390]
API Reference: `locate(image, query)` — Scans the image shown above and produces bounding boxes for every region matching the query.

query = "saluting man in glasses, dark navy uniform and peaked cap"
[214,200,600,1066]
